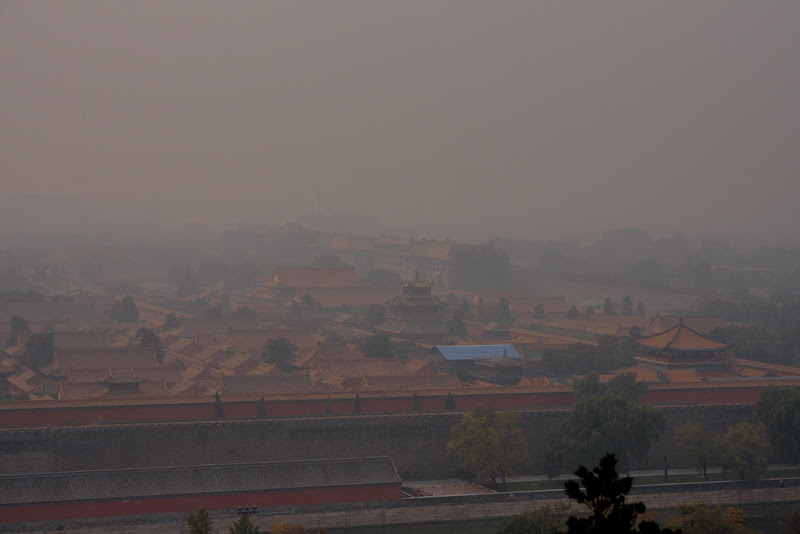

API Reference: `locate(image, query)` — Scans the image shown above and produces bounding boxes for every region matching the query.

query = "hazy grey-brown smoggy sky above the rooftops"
[0,0,800,244]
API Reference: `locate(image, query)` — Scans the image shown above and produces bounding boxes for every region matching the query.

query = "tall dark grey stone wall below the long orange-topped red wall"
[0,405,752,480]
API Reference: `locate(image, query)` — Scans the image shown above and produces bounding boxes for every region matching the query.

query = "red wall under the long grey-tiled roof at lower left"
[0,484,402,523]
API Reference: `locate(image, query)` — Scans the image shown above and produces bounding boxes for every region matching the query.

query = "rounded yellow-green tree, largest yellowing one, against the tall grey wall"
[447,405,529,486]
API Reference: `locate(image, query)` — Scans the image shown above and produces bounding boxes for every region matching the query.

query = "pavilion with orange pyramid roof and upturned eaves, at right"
[634,319,731,369]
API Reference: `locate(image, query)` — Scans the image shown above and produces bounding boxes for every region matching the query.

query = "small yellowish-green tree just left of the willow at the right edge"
[724,421,769,480]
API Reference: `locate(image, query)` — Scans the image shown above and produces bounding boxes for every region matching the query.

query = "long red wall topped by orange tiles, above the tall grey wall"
[0,385,764,428]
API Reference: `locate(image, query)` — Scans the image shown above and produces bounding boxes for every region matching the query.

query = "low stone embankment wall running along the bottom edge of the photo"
[3,479,800,534]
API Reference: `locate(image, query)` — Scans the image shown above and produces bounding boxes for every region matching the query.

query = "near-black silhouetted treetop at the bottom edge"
[564,453,681,534]
